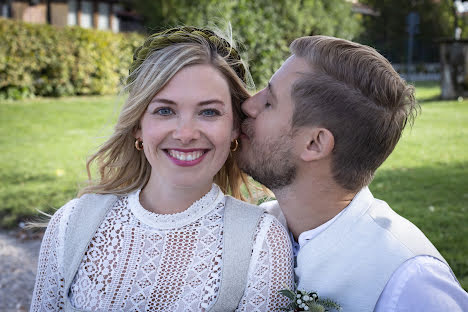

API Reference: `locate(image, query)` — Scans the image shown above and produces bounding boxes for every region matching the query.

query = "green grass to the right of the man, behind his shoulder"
[370,83,468,289]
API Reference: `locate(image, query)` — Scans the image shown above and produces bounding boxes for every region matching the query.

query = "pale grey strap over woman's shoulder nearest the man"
[210,196,264,312]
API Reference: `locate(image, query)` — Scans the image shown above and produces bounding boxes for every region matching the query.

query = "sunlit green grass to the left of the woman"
[0,97,118,227]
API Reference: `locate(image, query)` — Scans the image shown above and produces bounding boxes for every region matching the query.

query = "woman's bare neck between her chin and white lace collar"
[140,179,212,214]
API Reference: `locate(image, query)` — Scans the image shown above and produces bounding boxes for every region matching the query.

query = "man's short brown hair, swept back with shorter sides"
[290,36,419,191]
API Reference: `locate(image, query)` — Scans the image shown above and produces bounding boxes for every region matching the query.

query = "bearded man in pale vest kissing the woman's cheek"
[239,36,468,312]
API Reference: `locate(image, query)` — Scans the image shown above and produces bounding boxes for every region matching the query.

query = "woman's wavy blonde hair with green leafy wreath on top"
[78,27,253,199]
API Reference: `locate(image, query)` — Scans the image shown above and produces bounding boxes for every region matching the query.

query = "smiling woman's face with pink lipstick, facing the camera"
[136,64,238,187]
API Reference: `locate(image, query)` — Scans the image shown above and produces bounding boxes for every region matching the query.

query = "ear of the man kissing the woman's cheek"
[300,128,335,161]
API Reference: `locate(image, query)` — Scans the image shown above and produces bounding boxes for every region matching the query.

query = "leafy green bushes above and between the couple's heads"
[134,0,360,86]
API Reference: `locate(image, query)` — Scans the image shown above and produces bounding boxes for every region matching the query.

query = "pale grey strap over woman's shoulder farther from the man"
[63,194,117,301]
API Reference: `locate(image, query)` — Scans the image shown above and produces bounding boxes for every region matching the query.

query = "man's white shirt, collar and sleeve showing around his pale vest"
[260,201,468,312]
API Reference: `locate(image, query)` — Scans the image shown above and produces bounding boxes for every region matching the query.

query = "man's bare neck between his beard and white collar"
[273,181,356,241]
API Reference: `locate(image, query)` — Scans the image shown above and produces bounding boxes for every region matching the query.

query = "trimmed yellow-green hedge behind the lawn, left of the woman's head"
[0,18,143,99]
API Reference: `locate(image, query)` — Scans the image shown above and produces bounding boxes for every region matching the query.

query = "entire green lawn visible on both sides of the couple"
[0,83,468,289]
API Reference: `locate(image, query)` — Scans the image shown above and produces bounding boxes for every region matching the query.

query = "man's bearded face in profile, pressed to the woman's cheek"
[239,55,309,190]
